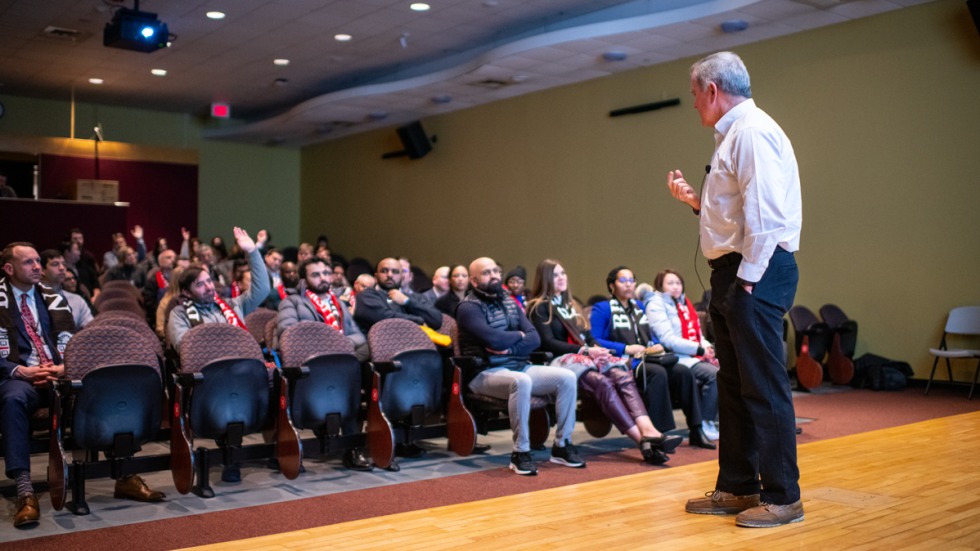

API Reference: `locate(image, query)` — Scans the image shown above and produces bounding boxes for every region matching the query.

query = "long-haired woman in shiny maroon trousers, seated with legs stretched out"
[527,259,681,465]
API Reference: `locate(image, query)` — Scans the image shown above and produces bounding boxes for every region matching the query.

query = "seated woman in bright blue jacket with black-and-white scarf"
[591,266,716,450]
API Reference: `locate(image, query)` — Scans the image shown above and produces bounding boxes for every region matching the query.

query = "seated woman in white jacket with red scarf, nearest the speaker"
[646,270,718,440]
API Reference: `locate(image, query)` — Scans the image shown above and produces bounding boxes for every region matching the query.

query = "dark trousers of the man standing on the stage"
[709,248,800,505]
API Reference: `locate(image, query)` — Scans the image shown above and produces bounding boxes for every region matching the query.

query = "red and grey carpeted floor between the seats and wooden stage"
[0,387,980,551]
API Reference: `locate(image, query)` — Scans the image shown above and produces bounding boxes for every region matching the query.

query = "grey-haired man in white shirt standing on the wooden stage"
[667,52,803,528]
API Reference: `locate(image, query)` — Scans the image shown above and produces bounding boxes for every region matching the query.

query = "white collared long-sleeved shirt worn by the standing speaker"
[701,99,803,282]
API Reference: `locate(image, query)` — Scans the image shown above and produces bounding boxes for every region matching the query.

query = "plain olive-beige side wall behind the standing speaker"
[300,0,980,376]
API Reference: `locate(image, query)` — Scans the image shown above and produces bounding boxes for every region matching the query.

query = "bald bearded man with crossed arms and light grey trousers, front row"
[456,258,585,475]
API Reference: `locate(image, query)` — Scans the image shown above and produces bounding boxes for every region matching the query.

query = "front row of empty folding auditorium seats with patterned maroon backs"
[23,286,580,514]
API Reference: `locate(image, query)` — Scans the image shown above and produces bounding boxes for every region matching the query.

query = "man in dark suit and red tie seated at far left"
[0,242,75,527]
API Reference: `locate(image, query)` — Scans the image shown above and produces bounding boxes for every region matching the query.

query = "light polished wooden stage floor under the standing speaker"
[184,412,980,551]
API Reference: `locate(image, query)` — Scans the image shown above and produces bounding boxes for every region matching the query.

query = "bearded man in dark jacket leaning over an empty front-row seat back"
[354,258,442,334]
